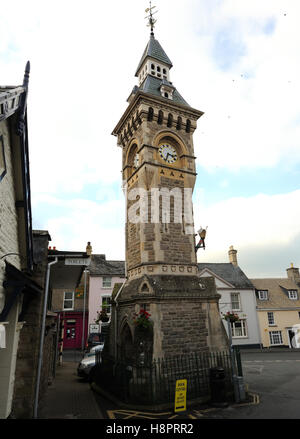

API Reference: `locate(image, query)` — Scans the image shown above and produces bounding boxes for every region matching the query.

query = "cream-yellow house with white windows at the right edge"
[251,265,300,348]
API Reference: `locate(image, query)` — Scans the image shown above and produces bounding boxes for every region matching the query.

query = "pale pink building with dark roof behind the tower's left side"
[88,255,125,332]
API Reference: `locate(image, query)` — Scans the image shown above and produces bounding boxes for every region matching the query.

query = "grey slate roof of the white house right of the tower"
[198,262,254,289]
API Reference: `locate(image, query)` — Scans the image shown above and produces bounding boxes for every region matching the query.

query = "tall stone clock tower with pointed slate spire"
[109,21,227,358]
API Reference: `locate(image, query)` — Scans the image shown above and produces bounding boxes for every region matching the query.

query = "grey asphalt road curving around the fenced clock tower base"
[64,350,300,419]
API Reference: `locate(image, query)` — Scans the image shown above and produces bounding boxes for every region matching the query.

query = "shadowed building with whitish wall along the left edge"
[0,62,53,418]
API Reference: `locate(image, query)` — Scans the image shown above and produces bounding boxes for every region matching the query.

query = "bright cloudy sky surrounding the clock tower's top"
[0,0,300,278]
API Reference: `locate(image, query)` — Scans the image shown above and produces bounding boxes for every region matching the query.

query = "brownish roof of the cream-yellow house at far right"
[251,278,300,309]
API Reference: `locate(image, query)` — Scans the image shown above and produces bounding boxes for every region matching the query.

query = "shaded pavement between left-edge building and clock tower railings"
[38,352,104,419]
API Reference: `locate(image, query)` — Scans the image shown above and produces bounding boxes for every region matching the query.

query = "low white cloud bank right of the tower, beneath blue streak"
[194,190,300,277]
